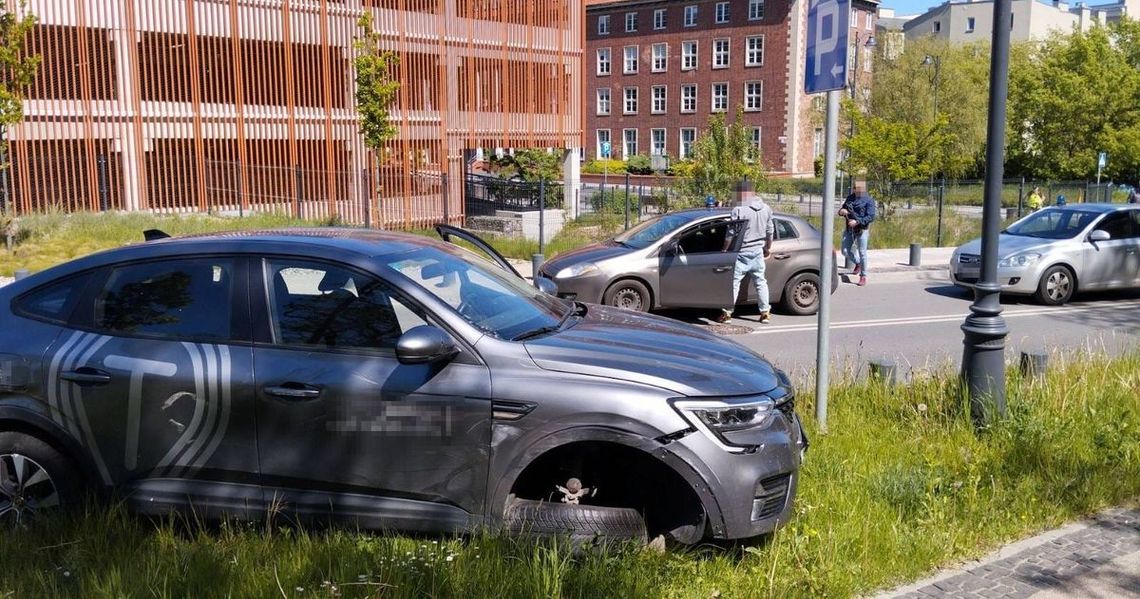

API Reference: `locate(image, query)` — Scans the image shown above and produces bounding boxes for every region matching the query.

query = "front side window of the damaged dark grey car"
[266,259,426,350]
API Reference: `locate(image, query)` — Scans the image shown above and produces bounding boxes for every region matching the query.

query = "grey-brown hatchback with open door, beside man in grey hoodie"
[539,209,839,315]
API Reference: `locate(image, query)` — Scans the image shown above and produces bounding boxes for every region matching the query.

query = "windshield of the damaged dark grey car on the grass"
[384,246,573,340]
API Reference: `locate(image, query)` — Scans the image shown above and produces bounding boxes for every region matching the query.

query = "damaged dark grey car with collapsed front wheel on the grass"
[0,228,807,543]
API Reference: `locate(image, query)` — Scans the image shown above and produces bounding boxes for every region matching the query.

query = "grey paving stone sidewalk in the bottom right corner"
[879,509,1140,599]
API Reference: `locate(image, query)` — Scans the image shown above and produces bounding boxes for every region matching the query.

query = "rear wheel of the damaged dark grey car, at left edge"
[0,431,83,526]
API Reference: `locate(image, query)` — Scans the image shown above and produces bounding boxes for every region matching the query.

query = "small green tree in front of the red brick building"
[674,106,766,204]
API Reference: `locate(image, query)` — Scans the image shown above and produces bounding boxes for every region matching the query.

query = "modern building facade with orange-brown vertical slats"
[0,0,585,227]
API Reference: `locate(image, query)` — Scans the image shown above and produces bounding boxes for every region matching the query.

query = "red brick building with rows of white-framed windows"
[584,0,878,175]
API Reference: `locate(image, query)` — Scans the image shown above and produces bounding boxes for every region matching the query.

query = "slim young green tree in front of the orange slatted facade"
[352,11,400,151]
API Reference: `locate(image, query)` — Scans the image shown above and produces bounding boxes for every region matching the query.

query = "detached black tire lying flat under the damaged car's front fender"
[503,499,648,543]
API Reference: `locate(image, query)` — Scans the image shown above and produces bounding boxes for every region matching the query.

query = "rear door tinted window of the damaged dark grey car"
[95,258,234,340]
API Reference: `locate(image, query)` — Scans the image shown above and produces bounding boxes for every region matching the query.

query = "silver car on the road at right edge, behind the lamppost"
[950,204,1140,306]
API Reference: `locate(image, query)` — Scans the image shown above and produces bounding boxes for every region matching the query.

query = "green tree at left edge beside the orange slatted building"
[0,2,40,215]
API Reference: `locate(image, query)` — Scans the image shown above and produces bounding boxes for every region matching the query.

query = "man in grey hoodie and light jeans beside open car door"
[716,179,775,323]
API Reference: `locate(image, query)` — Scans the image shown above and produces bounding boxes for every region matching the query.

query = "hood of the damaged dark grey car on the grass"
[526,305,779,397]
